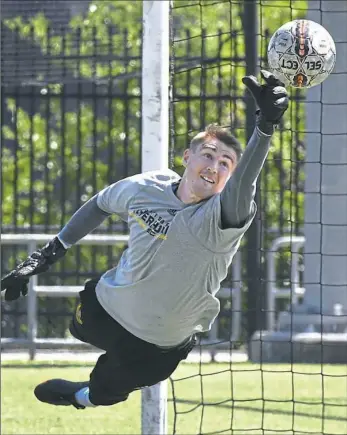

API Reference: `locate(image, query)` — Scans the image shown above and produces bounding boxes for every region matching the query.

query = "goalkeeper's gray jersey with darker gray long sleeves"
[58,129,270,346]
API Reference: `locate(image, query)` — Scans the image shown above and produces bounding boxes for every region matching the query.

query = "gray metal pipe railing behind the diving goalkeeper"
[1,234,305,359]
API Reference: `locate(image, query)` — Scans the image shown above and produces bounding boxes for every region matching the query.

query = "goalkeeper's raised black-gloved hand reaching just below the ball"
[242,70,289,135]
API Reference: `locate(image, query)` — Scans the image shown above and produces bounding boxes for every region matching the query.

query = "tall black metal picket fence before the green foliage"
[1,11,304,343]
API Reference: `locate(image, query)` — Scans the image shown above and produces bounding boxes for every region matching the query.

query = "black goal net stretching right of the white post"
[169,0,347,435]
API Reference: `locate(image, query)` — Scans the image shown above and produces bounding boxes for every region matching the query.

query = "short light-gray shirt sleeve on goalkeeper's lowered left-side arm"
[97,176,139,220]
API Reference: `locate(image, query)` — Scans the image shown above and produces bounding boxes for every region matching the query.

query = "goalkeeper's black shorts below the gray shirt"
[70,279,196,405]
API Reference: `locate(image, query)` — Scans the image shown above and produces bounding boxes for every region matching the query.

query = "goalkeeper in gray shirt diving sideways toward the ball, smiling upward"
[1,71,288,409]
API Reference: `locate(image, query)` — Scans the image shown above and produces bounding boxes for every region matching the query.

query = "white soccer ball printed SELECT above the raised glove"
[267,20,336,88]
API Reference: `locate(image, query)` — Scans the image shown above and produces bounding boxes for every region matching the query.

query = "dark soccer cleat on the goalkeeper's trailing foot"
[34,379,89,409]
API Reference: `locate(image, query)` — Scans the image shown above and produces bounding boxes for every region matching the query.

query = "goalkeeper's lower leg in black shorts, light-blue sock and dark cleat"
[35,336,194,409]
